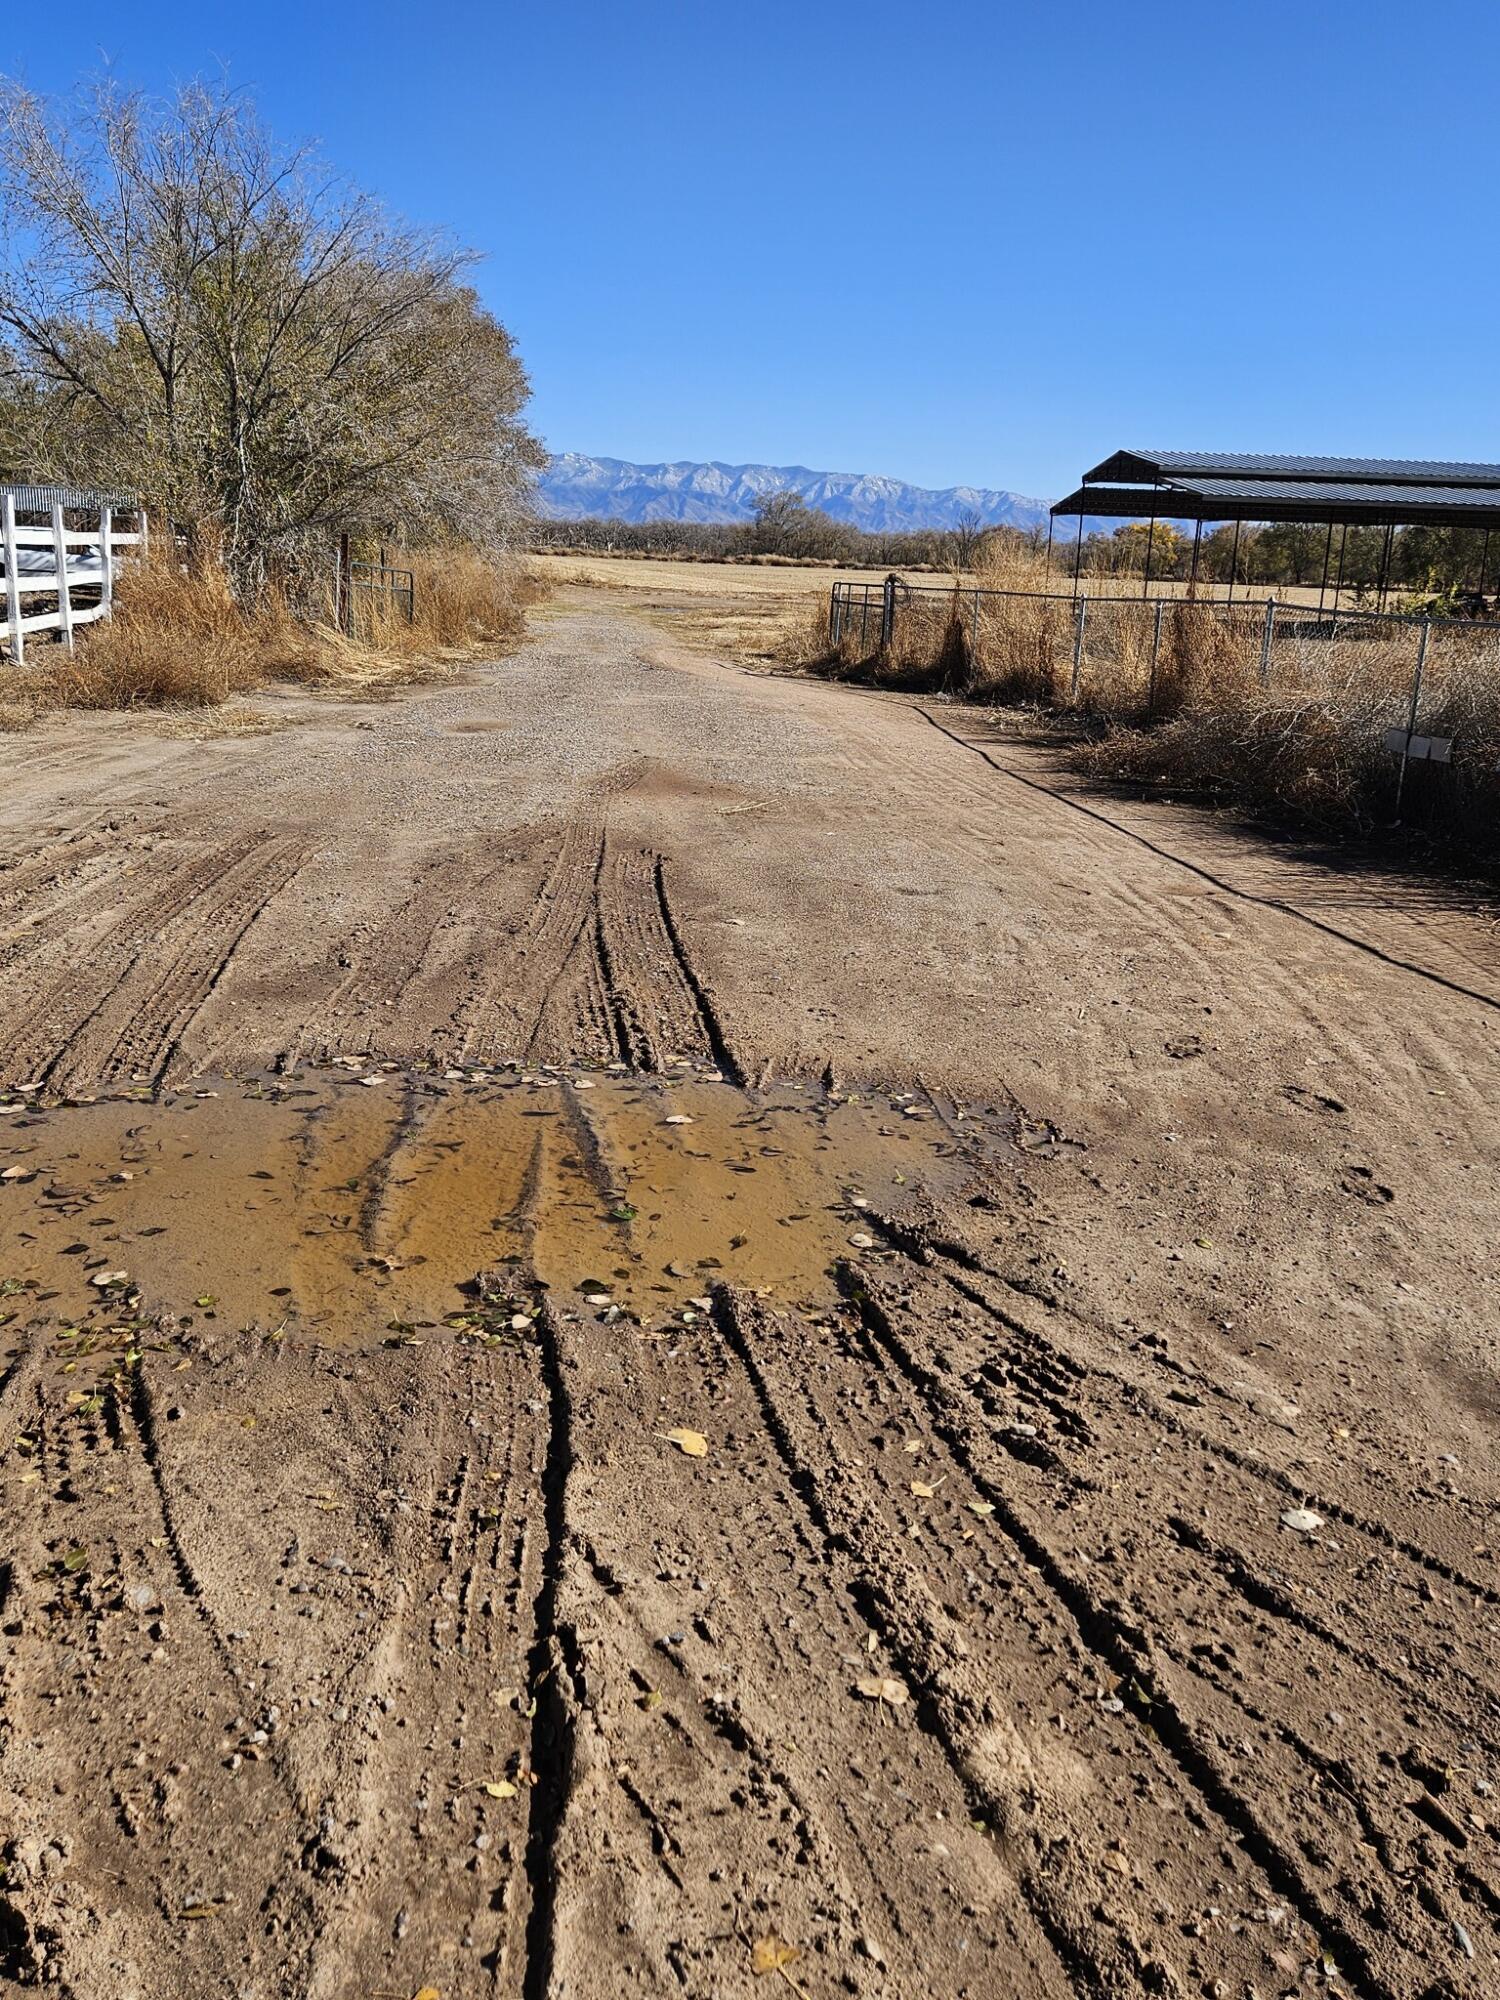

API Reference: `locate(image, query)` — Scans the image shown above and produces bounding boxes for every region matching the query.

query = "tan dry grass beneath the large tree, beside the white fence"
[11,546,538,728]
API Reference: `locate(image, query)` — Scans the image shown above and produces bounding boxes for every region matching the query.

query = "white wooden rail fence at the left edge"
[0,486,146,666]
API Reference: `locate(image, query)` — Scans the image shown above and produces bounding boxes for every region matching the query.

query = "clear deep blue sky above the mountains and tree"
[0,0,1500,496]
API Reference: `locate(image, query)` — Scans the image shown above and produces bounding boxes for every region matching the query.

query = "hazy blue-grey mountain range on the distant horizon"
[536,452,1048,534]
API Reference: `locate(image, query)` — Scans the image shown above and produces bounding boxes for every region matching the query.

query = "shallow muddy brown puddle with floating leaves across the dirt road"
[0,1058,1008,1346]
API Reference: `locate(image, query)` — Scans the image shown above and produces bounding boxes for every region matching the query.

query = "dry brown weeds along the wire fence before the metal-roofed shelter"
[828,578,1500,856]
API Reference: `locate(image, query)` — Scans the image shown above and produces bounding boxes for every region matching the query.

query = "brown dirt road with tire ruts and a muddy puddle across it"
[0,592,1500,2000]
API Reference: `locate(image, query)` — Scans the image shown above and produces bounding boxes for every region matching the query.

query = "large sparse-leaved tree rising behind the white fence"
[0,82,542,590]
